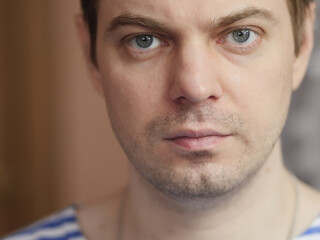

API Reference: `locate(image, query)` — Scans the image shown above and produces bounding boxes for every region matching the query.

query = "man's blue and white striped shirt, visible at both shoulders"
[0,206,320,240]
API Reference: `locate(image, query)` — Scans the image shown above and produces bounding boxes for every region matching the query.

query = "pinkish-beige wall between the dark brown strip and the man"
[51,0,126,205]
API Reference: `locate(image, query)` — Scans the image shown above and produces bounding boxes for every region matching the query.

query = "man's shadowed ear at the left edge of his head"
[75,14,104,96]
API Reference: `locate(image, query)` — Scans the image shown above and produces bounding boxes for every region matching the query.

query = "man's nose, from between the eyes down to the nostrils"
[169,41,223,103]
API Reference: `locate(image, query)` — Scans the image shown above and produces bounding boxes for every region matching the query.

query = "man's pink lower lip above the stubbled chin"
[169,136,228,150]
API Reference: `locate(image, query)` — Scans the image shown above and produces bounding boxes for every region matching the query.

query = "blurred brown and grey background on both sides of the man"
[0,0,320,235]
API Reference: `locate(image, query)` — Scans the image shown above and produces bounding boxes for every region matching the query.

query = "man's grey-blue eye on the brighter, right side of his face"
[226,29,258,45]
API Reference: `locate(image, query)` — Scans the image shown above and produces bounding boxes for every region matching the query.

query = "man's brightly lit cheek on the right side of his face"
[224,54,292,141]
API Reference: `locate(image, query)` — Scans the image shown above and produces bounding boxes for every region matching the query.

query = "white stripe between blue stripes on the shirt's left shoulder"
[3,223,79,240]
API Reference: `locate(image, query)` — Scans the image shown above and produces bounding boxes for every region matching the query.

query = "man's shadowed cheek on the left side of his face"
[101,55,165,132]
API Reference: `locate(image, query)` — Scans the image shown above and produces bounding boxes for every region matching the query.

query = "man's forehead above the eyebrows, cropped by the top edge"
[98,0,290,26]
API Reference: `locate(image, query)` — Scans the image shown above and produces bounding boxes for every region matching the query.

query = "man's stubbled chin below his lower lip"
[131,153,263,201]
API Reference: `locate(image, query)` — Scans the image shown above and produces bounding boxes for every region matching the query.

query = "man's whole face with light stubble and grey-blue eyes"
[93,0,304,199]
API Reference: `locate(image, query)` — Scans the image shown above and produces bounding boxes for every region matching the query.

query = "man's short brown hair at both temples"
[81,0,313,62]
